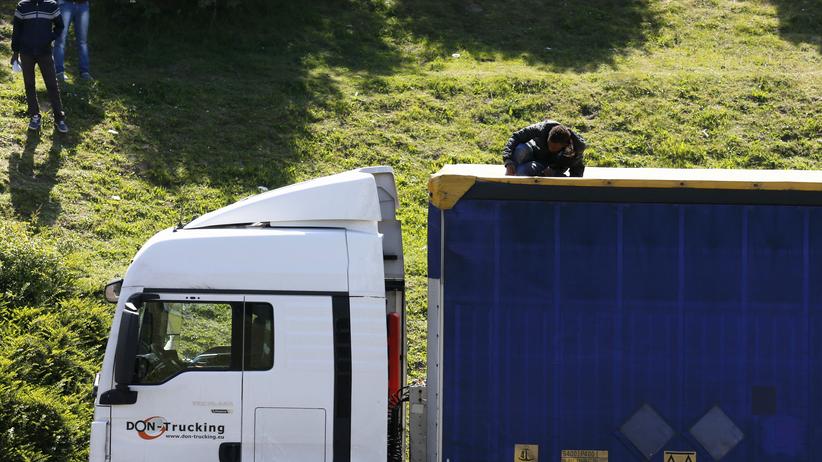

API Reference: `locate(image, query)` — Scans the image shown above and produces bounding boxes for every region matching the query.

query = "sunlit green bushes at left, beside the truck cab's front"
[0,221,111,462]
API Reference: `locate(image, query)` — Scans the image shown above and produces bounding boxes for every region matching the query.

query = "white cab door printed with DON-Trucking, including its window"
[111,293,245,462]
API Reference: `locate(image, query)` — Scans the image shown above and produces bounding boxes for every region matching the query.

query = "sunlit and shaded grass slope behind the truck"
[0,0,822,460]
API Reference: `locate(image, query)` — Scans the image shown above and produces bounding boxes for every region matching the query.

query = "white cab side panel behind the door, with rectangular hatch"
[243,295,338,462]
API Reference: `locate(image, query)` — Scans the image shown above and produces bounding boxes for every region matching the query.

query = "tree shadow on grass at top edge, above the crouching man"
[388,0,659,71]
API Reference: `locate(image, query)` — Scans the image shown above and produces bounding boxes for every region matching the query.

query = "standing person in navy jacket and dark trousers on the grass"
[11,0,68,133]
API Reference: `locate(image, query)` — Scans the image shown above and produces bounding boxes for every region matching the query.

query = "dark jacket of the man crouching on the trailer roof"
[502,120,587,176]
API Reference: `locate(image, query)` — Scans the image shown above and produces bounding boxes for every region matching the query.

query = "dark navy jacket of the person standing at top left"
[11,0,63,56]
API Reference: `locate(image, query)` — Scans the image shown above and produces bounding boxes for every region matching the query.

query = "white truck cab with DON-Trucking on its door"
[89,167,405,462]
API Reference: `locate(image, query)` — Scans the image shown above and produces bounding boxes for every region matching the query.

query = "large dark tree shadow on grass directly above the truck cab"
[92,1,402,199]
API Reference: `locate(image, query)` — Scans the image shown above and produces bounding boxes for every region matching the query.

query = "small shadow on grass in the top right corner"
[769,0,822,53]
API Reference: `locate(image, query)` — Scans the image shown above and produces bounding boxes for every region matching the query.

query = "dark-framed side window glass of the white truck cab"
[133,301,274,385]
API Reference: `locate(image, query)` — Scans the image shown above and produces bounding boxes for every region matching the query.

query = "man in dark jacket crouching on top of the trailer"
[502,120,586,177]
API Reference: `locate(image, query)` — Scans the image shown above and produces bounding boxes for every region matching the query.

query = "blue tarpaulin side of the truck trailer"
[444,200,822,462]
